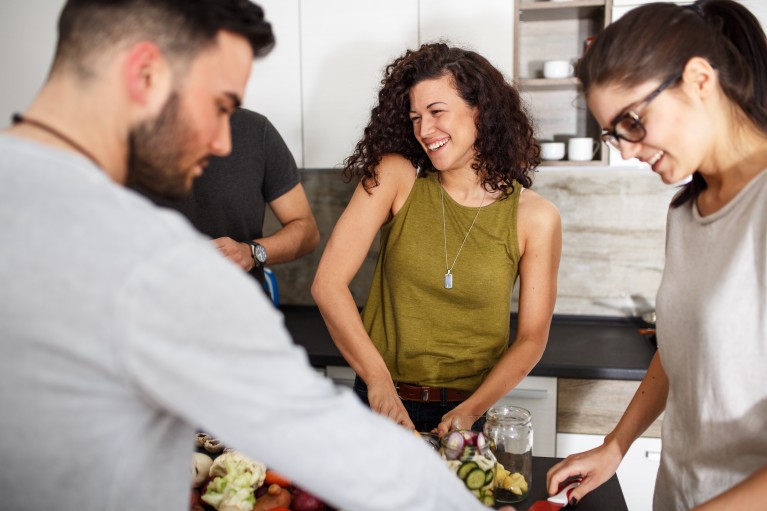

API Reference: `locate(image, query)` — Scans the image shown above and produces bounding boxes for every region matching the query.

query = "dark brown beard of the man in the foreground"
[128,92,206,199]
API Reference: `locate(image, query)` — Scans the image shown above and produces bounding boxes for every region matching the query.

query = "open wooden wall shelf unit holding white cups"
[514,0,612,166]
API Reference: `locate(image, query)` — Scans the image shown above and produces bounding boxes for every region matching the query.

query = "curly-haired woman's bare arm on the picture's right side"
[437,190,562,435]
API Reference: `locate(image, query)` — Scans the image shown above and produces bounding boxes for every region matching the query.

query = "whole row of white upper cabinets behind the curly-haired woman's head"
[244,0,514,169]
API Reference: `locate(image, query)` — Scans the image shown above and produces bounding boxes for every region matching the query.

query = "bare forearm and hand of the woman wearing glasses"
[546,353,668,509]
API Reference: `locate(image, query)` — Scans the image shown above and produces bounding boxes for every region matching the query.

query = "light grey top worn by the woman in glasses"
[654,171,767,511]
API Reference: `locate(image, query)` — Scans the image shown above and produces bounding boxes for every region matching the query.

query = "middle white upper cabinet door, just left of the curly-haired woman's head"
[300,0,418,168]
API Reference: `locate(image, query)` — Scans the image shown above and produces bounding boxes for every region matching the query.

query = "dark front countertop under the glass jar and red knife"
[508,456,628,511]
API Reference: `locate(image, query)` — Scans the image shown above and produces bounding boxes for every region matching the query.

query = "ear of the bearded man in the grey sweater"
[123,41,171,113]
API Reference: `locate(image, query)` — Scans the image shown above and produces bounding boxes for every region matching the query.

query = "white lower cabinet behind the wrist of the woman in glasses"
[556,433,661,511]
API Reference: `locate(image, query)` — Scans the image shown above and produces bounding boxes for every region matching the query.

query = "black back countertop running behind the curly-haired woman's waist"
[280,305,655,380]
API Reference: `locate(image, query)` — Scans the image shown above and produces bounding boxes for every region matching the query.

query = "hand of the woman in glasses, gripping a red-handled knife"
[546,442,623,508]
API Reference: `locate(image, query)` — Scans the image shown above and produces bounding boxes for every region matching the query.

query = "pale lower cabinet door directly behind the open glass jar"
[496,376,557,457]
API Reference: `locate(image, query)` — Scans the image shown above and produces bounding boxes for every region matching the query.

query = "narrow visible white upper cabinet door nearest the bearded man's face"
[248,0,304,168]
